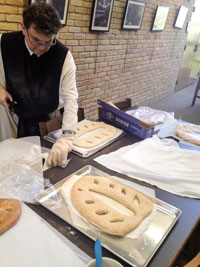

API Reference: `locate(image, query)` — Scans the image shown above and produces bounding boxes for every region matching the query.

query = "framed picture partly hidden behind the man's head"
[30,0,69,24]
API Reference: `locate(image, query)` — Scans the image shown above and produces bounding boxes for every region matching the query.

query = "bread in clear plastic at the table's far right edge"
[175,123,200,145]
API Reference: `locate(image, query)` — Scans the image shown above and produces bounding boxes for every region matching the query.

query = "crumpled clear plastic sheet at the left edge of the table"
[0,136,44,203]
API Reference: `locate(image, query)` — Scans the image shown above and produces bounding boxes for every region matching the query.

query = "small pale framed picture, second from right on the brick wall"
[152,6,169,31]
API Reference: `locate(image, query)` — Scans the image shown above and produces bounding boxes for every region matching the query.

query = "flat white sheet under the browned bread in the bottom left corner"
[0,203,91,267]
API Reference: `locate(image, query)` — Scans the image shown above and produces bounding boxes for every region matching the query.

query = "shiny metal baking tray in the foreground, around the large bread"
[37,165,181,267]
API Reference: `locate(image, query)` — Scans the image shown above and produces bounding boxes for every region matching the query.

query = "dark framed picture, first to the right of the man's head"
[90,0,114,32]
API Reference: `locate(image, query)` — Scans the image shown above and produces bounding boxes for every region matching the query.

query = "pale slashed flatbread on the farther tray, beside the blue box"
[73,121,117,148]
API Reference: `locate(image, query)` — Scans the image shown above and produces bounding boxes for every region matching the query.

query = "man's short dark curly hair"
[23,3,61,35]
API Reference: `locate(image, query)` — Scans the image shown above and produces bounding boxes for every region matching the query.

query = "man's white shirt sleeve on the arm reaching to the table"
[60,50,78,132]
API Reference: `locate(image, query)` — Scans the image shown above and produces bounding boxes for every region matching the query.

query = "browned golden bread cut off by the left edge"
[0,198,21,235]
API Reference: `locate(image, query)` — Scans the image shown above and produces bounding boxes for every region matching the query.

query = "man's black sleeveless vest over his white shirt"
[1,31,68,118]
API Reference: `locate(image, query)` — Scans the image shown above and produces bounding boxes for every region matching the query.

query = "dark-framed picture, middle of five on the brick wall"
[122,0,145,30]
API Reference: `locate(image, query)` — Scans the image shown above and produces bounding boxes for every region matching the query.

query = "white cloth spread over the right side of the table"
[94,135,200,198]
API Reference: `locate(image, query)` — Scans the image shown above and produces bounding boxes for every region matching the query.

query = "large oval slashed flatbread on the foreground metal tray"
[62,175,153,235]
